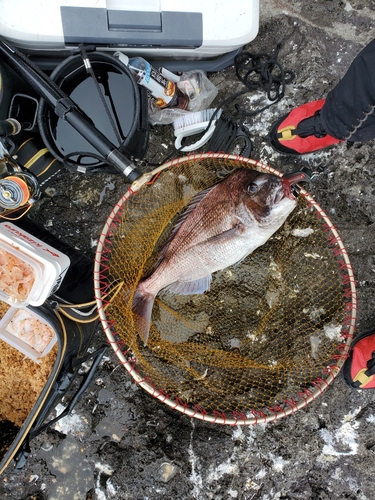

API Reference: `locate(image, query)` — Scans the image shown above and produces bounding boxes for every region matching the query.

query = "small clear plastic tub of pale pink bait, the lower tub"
[0,307,57,362]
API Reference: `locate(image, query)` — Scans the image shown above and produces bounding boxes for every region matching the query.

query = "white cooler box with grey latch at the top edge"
[0,0,259,71]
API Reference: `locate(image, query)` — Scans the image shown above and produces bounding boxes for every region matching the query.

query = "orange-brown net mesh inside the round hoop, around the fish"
[96,157,356,414]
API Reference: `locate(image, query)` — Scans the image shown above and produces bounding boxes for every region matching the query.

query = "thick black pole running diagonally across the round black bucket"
[0,38,142,182]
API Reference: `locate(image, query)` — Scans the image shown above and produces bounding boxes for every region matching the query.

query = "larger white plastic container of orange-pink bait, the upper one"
[0,222,70,307]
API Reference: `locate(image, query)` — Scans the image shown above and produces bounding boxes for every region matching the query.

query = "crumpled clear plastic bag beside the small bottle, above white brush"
[148,69,218,125]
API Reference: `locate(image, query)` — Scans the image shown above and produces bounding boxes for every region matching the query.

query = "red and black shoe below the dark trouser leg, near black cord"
[269,99,343,155]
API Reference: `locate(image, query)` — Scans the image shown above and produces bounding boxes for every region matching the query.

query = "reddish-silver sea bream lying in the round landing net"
[133,168,297,345]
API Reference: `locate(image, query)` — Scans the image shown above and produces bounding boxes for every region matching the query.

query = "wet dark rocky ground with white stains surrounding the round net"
[0,0,375,500]
